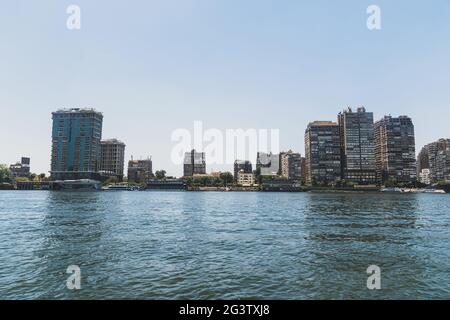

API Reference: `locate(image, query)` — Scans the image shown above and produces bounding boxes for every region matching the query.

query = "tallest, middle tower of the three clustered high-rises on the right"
[338,107,376,184]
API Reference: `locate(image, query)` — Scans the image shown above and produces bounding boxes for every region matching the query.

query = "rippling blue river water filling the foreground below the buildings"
[0,191,450,299]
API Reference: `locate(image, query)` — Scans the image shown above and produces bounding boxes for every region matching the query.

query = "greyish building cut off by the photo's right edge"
[417,139,450,184]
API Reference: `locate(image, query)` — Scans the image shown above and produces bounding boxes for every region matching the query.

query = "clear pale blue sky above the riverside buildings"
[0,0,450,175]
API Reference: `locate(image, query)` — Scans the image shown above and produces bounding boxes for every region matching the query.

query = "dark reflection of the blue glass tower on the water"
[35,192,107,299]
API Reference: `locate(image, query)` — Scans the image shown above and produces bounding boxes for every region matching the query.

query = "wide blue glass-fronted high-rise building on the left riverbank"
[51,108,103,180]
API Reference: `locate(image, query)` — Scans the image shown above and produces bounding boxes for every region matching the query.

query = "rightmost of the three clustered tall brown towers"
[374,116,417,183]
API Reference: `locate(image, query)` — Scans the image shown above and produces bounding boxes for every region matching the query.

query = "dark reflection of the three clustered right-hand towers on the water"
[305,194,424,299]
